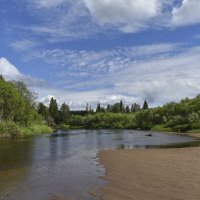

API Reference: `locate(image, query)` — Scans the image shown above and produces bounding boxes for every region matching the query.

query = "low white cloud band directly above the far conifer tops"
[37,88,142,110]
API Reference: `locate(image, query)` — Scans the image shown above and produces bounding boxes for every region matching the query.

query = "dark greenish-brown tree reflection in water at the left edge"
[0,138,34,197]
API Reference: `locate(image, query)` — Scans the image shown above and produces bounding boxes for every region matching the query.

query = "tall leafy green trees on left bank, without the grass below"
[0,76,41,126]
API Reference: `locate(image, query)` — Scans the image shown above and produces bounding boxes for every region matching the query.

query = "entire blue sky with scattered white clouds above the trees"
[0,0,200,109]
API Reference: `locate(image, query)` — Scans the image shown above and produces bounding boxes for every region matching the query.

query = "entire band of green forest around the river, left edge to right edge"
[0,76,200,137]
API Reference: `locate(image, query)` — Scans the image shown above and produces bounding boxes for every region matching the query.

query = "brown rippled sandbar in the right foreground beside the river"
[99,148,200,200]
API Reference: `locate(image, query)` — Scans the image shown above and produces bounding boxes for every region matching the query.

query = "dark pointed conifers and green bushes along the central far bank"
[38,97,148,129]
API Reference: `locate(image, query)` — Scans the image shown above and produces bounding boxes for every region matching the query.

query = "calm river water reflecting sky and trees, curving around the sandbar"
[0,130,199,200]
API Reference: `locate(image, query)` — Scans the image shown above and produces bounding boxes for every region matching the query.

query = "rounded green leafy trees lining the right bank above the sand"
[130,95,200,132]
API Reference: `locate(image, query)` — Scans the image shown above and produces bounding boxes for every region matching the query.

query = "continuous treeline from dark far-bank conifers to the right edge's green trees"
[38,92,200,132]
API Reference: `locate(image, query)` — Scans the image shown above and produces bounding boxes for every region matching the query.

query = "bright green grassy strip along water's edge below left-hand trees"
[0,121,53,138]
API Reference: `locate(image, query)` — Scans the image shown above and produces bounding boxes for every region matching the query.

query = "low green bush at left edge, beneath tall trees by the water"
[0,121,20,137]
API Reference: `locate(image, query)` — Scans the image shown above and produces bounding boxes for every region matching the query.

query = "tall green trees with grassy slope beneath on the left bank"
[0,76,51,137]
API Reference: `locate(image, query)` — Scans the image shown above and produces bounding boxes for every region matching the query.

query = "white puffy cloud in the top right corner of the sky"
[172,0,200,26]
